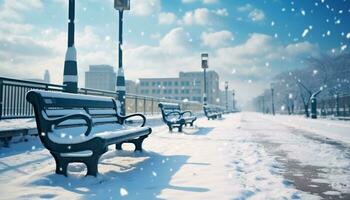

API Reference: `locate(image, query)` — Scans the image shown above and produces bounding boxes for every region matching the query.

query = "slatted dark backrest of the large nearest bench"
[27,90,119,135]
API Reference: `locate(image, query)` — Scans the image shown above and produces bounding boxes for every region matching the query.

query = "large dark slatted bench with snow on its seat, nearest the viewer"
[27,90,152,176]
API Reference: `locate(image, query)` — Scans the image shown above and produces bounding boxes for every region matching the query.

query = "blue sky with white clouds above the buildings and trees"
[0,0,350,102]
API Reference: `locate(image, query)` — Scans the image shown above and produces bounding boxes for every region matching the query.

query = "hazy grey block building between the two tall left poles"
[85,65,116,91]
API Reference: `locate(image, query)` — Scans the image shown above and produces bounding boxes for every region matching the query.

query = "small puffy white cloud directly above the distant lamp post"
[201,30,234,48]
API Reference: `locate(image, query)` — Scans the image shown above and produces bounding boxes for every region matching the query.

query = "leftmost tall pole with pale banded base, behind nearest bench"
[63,0,78,93]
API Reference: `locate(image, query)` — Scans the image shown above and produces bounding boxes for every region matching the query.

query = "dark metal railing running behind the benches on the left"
[0,77,203,120]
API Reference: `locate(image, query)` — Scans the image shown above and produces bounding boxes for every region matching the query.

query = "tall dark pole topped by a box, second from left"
[114,0,130,115]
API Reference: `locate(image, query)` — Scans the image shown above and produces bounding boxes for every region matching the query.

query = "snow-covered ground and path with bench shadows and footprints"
[0,113,350,199]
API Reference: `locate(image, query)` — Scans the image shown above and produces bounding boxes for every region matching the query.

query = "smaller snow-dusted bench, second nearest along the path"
[158,102,197,132]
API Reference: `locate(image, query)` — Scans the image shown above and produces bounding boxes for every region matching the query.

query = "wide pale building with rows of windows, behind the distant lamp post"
[138,71,219,104]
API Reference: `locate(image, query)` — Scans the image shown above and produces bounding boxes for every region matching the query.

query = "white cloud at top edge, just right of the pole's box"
[130,0,161,16]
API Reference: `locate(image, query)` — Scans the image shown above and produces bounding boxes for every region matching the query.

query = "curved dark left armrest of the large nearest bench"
[43,113,92,136]
